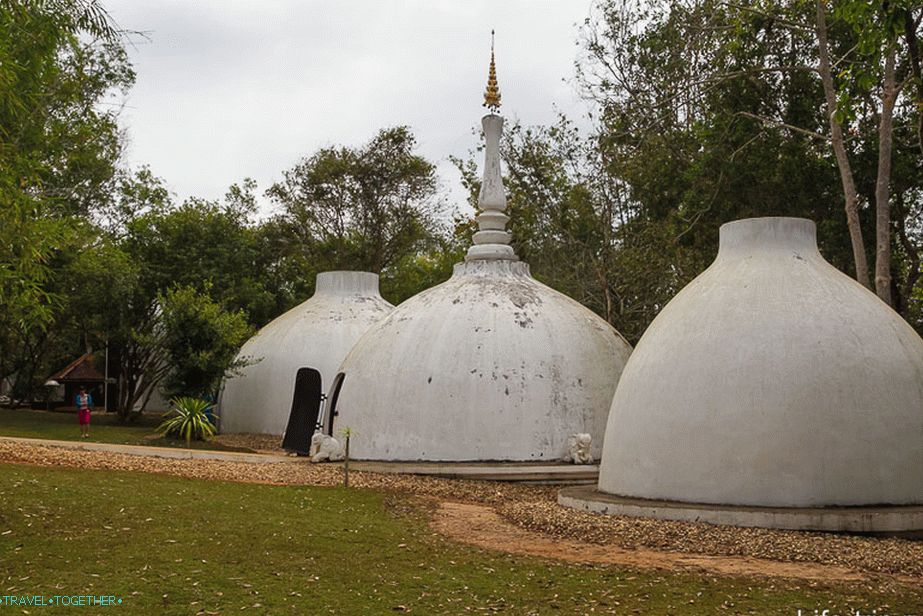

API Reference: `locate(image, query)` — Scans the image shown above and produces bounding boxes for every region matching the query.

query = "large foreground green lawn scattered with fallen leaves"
[0,465,923,615]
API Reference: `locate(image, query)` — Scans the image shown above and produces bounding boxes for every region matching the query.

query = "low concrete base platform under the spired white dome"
[349,460,599,486]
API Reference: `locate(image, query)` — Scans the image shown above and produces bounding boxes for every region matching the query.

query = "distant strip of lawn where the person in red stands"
[0,409,247,450]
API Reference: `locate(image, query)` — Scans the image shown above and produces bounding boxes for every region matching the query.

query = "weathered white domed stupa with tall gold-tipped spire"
[333,43,631,461]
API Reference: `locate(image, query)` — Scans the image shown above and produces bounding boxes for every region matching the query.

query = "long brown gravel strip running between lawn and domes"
[0,442,923,577]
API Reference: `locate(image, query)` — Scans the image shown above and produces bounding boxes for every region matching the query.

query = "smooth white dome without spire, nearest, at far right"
[599,218,923,507]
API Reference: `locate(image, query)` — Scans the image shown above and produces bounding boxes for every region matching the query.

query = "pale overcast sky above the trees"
[104,0,591,217]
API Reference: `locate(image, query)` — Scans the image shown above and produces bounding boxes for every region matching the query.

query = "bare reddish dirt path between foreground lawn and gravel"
[432,501,923,584]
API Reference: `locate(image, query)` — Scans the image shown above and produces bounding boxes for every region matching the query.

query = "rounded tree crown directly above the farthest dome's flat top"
[267,127,444,298]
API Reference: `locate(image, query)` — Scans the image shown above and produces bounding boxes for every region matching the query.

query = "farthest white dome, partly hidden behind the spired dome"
[218,271,394,434]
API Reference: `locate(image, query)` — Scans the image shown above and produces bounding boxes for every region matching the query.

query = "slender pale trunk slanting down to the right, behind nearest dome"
[816,0,872,289]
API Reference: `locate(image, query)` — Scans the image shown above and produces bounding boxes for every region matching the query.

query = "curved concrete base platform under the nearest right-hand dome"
[558,486,923,538]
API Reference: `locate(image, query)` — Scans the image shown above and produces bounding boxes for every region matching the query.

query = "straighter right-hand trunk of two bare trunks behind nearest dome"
[875,43,898,306]
